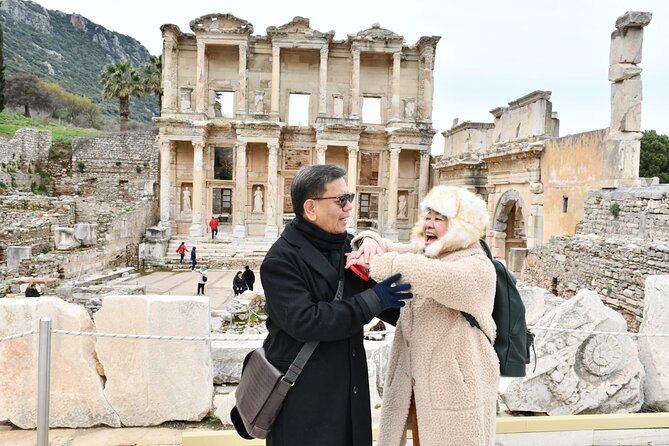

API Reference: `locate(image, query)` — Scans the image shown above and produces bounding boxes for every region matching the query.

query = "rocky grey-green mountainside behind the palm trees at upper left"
[0,0,158,123]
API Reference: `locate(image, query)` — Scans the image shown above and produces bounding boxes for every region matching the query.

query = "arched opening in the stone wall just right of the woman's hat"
[492,189,527,271]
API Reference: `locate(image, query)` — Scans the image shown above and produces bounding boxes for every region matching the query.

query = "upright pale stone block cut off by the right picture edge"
[639,275,669,412]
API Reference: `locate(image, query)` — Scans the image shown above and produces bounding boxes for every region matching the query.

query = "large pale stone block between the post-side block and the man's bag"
[94,296,213,426]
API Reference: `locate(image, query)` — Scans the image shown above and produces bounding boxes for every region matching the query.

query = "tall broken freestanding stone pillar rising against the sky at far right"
[602,11,652,187]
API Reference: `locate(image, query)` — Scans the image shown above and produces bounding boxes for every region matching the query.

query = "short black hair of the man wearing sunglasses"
[290,164,346,217]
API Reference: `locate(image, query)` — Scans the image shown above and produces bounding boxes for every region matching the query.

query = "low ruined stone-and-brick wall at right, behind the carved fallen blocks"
[521,186,669,322]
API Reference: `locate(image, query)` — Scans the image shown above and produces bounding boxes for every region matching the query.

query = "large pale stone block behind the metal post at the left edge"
[0,297,121,429]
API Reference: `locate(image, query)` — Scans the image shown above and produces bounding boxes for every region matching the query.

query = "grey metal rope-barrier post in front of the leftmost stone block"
[37,317,51,446]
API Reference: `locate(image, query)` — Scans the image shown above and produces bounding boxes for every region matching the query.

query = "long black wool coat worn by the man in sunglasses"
[260,225,396,446]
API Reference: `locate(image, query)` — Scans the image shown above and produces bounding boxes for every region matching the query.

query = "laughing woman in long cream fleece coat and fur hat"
[348,185,499,446]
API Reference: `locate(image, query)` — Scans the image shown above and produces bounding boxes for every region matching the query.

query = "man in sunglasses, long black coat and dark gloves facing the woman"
[231,165,413,446]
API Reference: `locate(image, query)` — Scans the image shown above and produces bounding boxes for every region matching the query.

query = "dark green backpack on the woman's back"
[462,240,534,378]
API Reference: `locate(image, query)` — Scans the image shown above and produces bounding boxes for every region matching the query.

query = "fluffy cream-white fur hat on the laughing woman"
[411,185,488,257]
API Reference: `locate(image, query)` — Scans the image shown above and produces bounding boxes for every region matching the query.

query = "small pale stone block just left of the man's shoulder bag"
[211,336,264,384]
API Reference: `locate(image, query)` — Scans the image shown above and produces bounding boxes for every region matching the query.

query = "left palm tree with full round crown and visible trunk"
[100,60,144,132]
